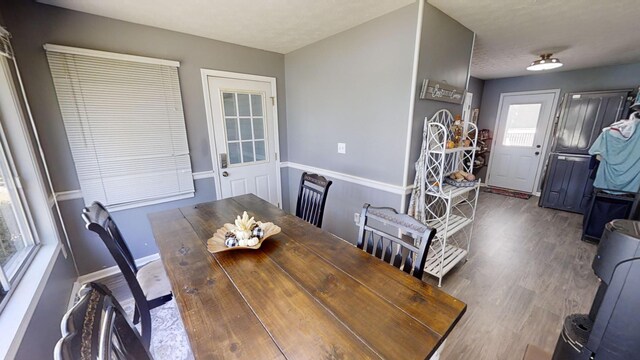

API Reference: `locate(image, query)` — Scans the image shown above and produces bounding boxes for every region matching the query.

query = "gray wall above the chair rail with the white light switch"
[285,4,418,184]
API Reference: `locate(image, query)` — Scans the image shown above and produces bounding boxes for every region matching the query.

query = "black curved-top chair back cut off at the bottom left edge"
[53,283,151,360]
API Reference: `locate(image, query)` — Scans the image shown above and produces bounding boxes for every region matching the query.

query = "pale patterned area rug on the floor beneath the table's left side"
[121,299,194,360]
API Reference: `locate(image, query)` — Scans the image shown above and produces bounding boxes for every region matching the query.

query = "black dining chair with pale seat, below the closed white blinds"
[82,201,172,347]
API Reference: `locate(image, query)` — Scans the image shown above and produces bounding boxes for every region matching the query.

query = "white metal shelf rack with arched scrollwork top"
[413,110,480,286]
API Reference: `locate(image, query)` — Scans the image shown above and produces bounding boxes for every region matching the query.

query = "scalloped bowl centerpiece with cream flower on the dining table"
[207,211,280,253]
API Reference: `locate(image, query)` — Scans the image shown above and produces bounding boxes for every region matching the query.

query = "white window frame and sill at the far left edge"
[0,27,70,359]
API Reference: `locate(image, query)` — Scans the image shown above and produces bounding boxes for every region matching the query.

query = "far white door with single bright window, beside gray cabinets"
[487,91,558,193]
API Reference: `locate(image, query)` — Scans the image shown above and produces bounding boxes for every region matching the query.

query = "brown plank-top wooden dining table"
[149,195,466,360]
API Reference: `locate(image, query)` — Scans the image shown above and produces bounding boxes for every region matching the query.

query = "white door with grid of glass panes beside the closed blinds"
[207,76,280,206]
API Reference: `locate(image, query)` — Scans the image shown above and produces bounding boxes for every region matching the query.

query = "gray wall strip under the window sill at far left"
[16,253,76,360]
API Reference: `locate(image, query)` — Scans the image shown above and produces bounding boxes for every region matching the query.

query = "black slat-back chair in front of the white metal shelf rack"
[356,204,436,279]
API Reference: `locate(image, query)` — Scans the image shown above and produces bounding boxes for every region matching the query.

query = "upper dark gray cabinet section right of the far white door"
[551,90,629,154]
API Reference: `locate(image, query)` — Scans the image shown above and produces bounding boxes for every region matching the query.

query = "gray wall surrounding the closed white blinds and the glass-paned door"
[0,0,287,274]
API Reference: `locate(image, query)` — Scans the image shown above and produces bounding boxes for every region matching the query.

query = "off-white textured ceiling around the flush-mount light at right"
[428,0,640,80]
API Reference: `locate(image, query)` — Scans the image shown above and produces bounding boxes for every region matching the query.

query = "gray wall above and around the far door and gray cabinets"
[478,63,640,190]
